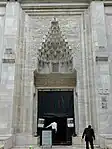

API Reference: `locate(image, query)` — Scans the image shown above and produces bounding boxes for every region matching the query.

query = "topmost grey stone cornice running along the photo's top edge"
[0,0,112,10]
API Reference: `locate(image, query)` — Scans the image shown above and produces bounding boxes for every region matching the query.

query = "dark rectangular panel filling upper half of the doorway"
[38,91,74,117]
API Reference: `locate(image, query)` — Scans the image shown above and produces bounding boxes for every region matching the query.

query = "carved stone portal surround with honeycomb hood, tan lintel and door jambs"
[33,18,78,137]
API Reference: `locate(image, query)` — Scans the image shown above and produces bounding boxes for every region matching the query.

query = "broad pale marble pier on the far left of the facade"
[0,3,20,134]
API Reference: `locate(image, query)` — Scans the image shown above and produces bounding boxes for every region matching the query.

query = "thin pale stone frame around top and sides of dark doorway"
[33,87,79,135]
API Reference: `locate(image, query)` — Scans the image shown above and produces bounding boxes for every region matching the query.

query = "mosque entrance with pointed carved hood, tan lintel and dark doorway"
[34,18,76,145]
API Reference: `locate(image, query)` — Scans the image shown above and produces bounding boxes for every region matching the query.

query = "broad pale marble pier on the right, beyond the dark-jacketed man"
[90,2,110,134]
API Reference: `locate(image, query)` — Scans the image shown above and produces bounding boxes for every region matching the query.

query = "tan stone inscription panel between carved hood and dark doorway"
[35,73,76,87]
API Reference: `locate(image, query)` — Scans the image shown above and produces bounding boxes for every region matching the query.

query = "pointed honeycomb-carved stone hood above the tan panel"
[38,18,73,71]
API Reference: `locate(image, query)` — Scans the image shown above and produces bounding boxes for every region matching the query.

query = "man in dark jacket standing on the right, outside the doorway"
[82,125,95,149]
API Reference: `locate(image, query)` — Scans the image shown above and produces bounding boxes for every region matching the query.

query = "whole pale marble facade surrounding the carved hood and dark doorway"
[0,1,112,148]
